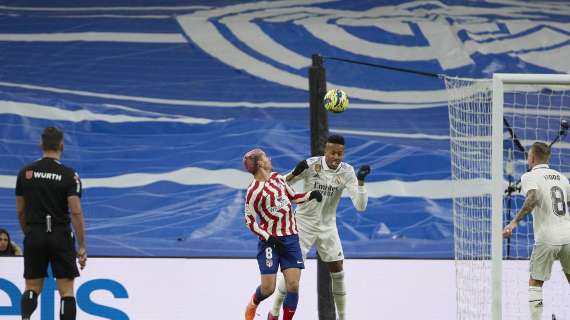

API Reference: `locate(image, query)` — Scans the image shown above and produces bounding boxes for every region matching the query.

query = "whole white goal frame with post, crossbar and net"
[445,74,570,320]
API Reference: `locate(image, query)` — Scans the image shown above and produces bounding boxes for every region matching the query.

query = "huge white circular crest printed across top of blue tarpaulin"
[177,0,570,103]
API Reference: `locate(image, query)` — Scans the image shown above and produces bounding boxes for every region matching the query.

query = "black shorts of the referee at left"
[24,226,79,279]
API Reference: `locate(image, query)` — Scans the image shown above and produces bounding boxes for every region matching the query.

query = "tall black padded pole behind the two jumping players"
[309,54,336,320]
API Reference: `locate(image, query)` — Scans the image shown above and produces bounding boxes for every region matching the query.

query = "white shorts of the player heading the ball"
[297,220,344,262]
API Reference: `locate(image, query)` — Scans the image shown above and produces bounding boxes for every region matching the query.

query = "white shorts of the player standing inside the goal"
[530,243,570,281]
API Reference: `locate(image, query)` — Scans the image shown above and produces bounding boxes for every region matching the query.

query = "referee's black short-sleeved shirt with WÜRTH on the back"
[16,158,81,226]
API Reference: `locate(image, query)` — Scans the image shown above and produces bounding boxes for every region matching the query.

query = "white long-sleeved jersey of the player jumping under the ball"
[289,156,368,232]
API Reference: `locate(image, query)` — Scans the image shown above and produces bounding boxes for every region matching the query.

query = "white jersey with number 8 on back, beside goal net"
[521,164,570,245]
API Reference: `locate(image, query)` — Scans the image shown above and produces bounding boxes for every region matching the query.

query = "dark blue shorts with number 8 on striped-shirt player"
[257,234,305,274]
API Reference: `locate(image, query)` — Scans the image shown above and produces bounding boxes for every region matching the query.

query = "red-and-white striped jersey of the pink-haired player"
[245,172,309,240]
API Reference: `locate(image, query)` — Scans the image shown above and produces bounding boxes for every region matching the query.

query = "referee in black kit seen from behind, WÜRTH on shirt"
[16,127,87,320]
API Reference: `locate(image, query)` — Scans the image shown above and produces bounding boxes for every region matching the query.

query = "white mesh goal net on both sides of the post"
[445,78,570,319]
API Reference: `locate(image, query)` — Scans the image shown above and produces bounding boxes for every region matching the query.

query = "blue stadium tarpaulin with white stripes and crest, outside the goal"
[0,0,570,258]
